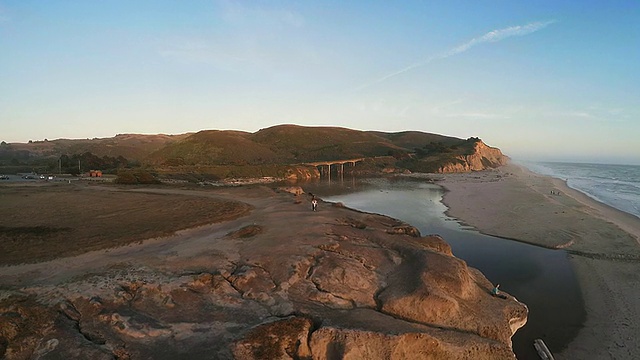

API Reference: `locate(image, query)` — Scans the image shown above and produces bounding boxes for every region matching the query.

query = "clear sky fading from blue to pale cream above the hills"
[0,0,640,164]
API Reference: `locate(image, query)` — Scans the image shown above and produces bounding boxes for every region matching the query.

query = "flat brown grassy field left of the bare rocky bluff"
[0,184,251,266]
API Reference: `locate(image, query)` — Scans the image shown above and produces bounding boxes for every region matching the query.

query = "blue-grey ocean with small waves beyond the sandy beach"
[520,162,640,218]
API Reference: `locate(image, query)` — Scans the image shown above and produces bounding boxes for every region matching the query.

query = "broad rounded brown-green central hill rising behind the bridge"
[147,125,406,166]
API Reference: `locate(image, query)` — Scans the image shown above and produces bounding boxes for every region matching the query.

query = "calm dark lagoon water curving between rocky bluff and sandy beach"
[303,178,584,359]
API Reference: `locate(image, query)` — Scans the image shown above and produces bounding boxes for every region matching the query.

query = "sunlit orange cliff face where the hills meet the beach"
[437,141,508,173]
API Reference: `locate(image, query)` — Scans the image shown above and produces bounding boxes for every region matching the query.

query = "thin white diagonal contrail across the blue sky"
[355,20,556,91]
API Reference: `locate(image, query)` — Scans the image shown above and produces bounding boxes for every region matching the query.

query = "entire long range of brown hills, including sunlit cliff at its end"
[0,125,506,179]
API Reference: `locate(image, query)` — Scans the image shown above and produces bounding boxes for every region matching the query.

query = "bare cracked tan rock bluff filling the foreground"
[0,186,528,360]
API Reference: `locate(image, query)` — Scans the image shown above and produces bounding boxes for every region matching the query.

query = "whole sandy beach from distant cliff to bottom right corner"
[439,164,640,359]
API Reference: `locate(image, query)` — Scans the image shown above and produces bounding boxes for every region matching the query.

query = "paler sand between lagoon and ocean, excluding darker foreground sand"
[435,164,640,259]
